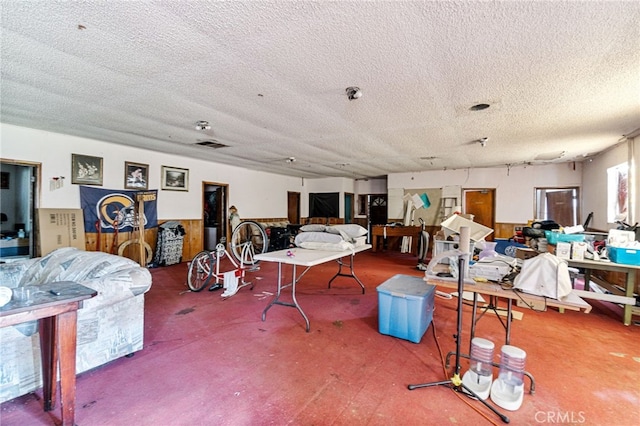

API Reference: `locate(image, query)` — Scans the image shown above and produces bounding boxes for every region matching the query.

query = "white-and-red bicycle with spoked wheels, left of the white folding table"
[187,221,268,297]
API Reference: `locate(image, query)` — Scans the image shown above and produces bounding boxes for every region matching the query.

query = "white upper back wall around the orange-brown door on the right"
[387,163,586,223]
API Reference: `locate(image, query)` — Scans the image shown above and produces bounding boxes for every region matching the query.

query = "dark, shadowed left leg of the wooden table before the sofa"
[39,316,58,411]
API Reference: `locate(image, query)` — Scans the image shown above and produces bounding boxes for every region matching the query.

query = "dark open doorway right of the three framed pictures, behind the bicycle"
[202,182,229,251]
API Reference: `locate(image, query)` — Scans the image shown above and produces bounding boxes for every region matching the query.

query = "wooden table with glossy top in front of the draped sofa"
[0,282,97,426]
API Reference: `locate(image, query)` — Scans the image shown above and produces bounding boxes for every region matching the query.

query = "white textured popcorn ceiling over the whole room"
[0,0,640,178]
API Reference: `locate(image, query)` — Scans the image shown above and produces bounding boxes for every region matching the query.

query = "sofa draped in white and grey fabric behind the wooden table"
[0,248,151,402]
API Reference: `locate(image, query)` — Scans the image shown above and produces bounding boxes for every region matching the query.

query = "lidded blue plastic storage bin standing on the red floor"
[377,274,436,343]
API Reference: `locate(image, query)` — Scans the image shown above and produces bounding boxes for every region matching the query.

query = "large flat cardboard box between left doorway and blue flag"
[36,209,85,256]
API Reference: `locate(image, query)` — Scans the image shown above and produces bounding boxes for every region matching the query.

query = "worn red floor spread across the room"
[0,253,640,426]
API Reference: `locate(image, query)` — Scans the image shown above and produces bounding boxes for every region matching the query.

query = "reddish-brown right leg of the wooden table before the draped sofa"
[57,311,78,426]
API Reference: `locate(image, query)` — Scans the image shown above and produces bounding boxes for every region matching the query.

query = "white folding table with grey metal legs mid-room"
[255,244,371,332]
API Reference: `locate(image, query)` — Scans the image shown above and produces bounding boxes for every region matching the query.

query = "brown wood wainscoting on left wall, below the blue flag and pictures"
[85,219,204,262]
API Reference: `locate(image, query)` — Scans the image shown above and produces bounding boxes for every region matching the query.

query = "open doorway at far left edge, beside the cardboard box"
[0,159,40,262]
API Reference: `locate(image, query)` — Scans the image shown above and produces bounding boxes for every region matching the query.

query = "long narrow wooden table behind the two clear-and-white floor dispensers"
[425,276,591,345]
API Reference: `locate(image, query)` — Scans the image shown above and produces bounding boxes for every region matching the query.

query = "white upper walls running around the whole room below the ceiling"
[7,123,640,229]
